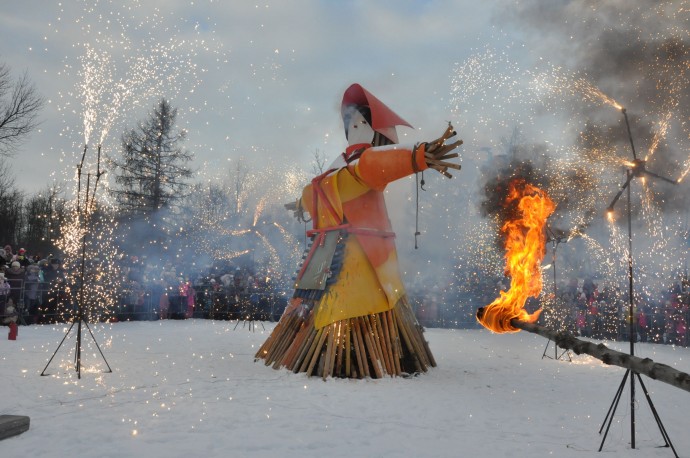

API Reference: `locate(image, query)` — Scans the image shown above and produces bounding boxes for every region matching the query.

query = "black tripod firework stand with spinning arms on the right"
[599,108,678,457]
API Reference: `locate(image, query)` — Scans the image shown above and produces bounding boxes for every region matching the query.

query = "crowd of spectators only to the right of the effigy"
[408,272,690,347]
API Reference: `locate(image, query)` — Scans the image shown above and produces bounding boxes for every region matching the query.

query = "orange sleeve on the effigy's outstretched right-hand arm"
[353,143,429,191]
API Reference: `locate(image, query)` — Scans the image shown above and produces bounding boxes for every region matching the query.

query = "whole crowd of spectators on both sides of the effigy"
[0,245,690,346]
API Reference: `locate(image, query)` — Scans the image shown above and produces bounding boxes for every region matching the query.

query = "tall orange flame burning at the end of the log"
[477,179,556,333]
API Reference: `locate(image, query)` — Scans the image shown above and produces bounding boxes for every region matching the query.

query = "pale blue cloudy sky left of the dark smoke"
[0,0,522,191]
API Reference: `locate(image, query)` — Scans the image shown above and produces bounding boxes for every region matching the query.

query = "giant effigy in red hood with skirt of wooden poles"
[256,84,462,378]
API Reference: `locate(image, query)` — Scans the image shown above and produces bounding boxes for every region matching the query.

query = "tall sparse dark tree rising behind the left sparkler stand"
[112,99,193,216]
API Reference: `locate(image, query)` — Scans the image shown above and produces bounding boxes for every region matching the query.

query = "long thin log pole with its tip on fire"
[510,319,690,391]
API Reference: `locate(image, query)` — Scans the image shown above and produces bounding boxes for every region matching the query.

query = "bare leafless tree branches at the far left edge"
[0,63,44,157]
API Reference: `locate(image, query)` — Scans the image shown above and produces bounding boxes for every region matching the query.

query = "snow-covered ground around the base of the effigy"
[0,320,690,458]
